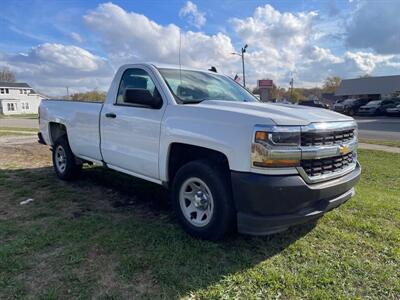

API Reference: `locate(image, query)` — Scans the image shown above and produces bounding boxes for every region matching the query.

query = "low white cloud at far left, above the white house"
[0,43,113,95]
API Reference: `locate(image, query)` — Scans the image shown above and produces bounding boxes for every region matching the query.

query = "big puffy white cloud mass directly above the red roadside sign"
[231,4,342,87]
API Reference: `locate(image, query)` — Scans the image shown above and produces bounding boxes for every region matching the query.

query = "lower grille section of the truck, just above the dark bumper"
[301,152,355,177]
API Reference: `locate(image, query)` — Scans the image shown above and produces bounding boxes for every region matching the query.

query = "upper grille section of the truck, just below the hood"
[301,129,354,146]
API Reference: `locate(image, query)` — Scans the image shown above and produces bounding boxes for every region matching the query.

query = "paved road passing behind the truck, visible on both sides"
[0,117,400,141]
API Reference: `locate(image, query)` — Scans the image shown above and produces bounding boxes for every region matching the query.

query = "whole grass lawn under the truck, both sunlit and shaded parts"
[0,145,400,299]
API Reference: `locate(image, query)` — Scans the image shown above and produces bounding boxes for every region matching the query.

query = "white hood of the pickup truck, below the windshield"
[194,100,353,125]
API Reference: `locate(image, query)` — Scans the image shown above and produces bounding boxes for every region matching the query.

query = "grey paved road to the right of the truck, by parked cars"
[357,117,400,141]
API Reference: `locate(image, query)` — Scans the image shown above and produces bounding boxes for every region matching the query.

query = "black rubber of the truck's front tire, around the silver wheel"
[171,160,236,240]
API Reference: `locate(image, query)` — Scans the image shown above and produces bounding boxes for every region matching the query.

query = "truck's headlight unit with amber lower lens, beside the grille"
[251,126,301,168]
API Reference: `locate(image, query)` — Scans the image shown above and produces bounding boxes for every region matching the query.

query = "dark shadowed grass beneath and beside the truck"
[0,167,315,298]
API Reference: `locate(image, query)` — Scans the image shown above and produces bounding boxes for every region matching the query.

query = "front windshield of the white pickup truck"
[159,69,257,104]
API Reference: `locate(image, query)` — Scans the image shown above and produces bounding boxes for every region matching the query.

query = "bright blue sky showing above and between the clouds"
[0,0,349,54]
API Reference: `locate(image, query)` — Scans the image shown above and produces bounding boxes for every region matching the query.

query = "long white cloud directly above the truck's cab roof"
[84,3,237,67]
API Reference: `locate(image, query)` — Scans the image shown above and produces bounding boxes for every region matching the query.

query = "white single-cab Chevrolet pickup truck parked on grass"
[39,63,361,240]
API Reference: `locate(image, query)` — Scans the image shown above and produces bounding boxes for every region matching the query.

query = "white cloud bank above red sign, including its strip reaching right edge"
[232,4,400,87]
